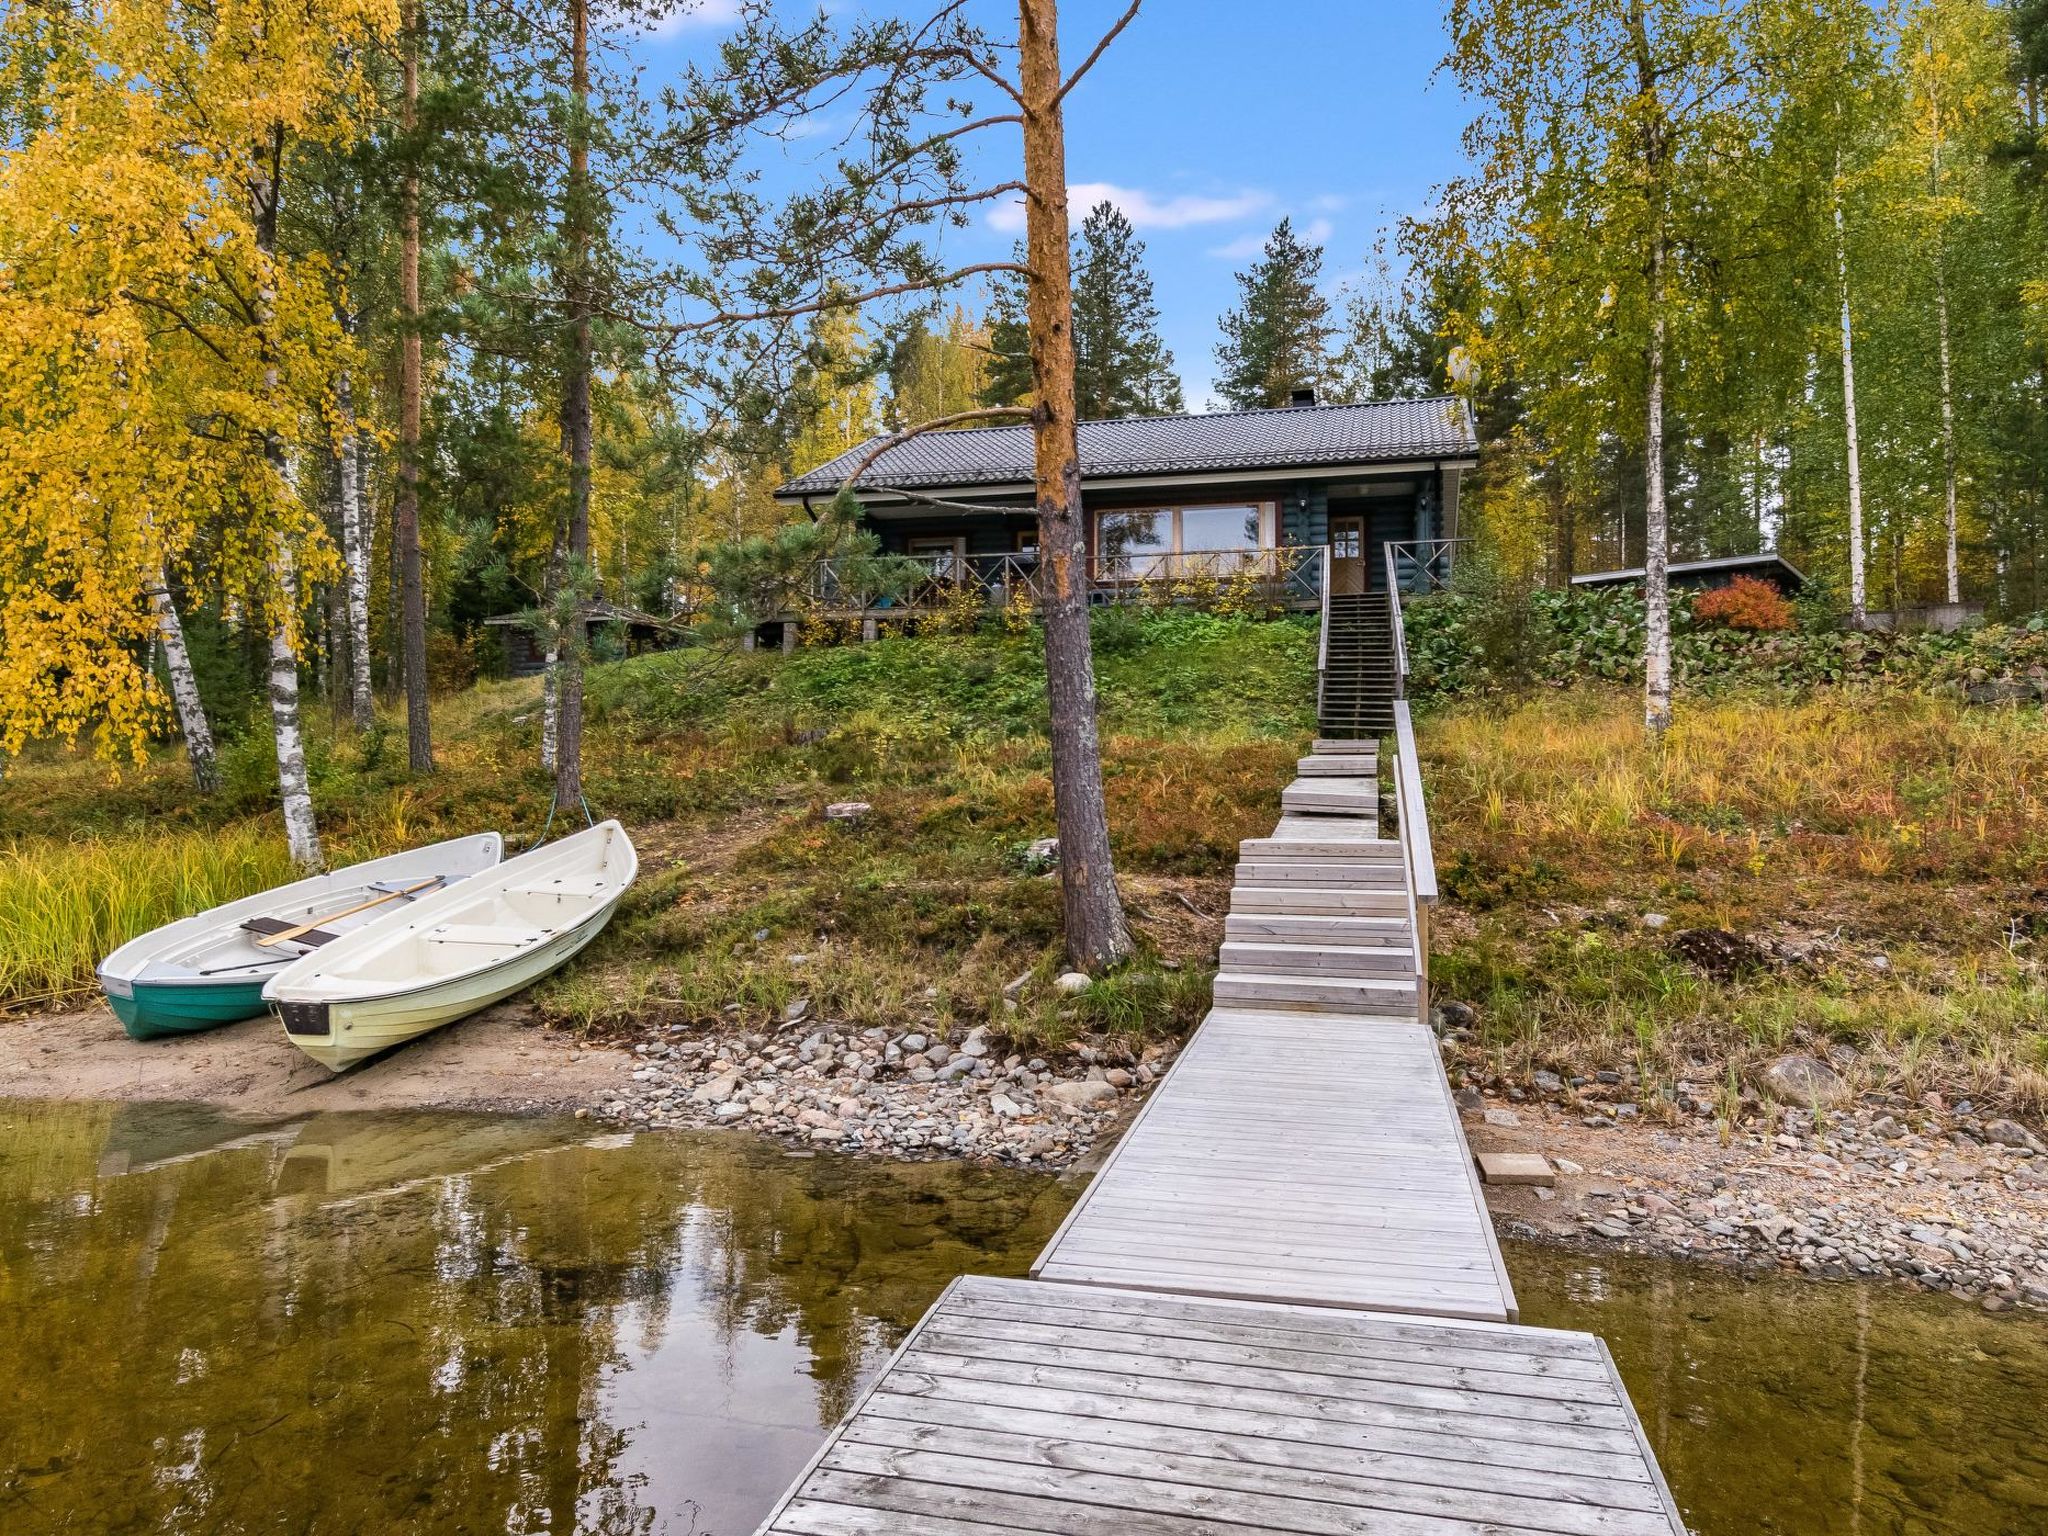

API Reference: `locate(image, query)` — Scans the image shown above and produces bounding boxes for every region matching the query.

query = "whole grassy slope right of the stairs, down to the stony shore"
[1421,690,2048,1112]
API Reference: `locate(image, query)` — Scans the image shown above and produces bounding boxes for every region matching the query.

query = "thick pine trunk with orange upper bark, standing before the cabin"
[1018,0,1130,969]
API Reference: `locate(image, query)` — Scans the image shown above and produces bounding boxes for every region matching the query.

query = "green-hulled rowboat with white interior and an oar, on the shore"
[100,831,504,1040]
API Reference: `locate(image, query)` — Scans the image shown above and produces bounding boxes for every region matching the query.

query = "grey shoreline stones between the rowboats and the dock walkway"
[580,1004,1167,1167]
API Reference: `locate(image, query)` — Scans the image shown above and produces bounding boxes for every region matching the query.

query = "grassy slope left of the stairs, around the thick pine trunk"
[0,612,1315,1049]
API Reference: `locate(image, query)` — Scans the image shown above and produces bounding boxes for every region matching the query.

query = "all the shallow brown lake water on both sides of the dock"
[0,1104,2048,1536]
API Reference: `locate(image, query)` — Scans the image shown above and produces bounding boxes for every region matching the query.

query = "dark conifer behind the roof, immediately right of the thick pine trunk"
[1073,203,1186,422]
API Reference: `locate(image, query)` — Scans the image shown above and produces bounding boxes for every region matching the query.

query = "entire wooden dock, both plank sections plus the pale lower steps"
[760,741,1686,1536]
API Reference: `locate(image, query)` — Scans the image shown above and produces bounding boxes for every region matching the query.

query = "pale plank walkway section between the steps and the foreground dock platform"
[1032,1008,1516,1321]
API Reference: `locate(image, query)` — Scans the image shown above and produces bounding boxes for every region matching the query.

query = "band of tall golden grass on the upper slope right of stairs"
[1423,690,2048,879]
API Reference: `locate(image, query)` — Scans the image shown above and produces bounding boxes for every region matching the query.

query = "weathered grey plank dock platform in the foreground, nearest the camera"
[762,1276,1686,1536]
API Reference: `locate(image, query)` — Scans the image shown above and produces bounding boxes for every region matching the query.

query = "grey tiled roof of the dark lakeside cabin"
[776,395,1479,496]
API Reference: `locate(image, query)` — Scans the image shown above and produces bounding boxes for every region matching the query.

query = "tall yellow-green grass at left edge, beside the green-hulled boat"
[0,825,293,1008]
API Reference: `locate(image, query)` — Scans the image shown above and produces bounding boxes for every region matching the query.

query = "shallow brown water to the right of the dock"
[1507,1245,2048,1536]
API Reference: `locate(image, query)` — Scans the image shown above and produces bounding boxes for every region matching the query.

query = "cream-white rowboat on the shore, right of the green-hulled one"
[262,821,639,1071]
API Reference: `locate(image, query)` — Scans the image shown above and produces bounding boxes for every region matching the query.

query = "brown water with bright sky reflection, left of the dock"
[0,1106,1065,1532]
